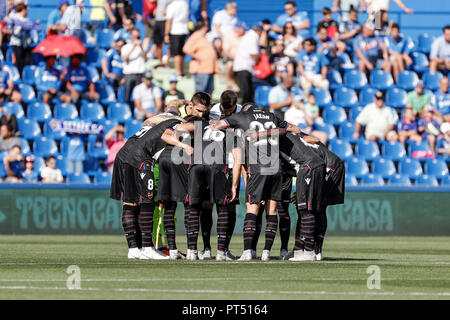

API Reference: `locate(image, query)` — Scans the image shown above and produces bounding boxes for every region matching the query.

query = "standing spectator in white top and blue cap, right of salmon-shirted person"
[223,21,248,90]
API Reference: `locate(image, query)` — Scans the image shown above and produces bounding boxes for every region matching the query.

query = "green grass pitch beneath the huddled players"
[0,235,450,300]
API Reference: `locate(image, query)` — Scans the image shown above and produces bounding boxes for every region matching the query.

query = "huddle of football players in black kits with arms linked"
[111,90,345,261]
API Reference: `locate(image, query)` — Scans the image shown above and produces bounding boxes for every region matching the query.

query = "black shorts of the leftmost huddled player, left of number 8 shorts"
[110,157,140,204]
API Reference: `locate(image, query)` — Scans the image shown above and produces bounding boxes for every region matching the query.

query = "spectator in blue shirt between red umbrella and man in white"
[102,39,125,90]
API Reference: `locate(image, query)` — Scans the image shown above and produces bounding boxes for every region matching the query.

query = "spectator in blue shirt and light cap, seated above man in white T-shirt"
[353,22,391,73]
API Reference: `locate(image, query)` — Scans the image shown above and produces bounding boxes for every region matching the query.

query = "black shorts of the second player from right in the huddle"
[297,165,325,211]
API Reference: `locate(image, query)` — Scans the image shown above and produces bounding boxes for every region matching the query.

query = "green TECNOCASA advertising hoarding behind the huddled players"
[0,188,450,236]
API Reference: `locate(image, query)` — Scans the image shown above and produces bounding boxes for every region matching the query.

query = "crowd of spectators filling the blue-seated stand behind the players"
[0,0,450,182]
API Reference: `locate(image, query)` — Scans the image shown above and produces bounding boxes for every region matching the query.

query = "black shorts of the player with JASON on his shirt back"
[245,172,281,204]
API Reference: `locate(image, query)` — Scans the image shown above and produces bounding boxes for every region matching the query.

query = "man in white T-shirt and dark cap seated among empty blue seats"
[353,91,398,141]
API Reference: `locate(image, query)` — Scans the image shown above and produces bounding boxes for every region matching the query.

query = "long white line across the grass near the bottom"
[0,286,450,296]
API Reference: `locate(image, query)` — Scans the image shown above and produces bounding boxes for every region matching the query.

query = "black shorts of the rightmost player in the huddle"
[324,162,345,206]
